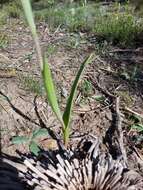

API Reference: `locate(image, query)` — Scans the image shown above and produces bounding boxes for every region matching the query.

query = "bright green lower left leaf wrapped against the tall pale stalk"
[42,55,64,126]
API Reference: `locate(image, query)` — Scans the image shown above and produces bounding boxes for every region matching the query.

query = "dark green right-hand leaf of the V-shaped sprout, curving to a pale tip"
[63,54,92,142]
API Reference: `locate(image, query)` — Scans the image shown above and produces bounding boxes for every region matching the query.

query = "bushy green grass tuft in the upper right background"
[93,13,143,47]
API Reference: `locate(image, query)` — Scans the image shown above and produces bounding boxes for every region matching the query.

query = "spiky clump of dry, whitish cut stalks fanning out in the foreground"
[0,136,143,190]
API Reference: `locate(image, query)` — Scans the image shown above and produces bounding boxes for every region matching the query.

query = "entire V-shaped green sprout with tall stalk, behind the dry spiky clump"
[21,0,92,146]
